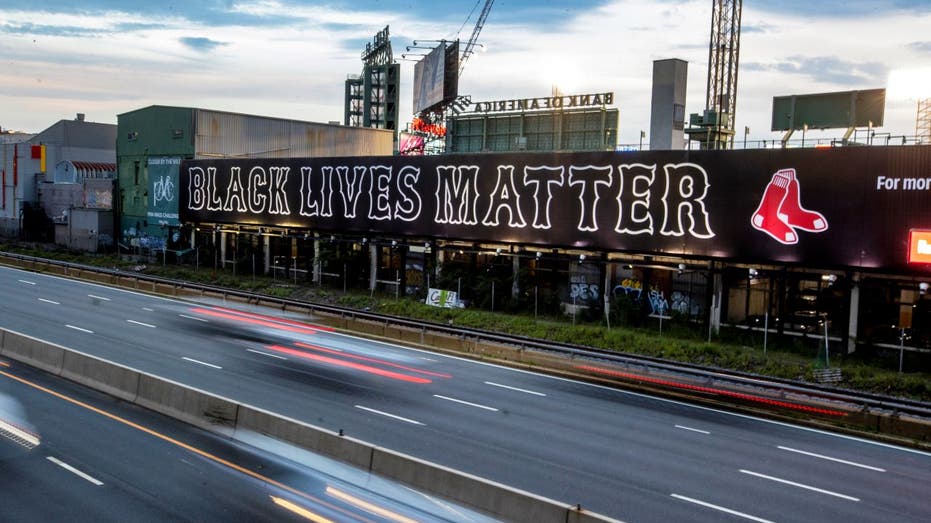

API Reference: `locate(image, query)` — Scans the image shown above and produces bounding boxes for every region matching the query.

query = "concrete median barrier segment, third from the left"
[136,374,239,436]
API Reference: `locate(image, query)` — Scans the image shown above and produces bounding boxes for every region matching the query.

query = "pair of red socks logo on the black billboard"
[750,169,828,245]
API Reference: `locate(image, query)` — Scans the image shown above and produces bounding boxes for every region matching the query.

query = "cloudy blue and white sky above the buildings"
[0,0,931,144]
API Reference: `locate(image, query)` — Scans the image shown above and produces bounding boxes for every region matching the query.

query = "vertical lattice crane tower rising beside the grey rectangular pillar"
[685,0,743,149]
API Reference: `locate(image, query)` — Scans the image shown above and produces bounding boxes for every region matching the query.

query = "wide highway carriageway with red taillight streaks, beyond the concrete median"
[0,268,931,523]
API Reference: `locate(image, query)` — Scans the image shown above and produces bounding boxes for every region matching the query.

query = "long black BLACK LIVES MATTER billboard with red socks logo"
[179,146,931,270]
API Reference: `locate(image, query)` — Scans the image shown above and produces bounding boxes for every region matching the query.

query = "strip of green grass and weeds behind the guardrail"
[0,244,931,402]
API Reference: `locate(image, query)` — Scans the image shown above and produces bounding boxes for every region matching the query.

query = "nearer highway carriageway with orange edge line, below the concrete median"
[0,352,491,523]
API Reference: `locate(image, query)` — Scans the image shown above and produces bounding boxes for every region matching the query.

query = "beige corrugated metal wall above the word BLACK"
[194,109,394,159]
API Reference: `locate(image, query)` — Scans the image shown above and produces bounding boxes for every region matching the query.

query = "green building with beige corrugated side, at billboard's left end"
[116,105,394,253]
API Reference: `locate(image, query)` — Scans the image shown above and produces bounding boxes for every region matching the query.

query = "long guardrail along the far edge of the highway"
[0,253,931,428]
